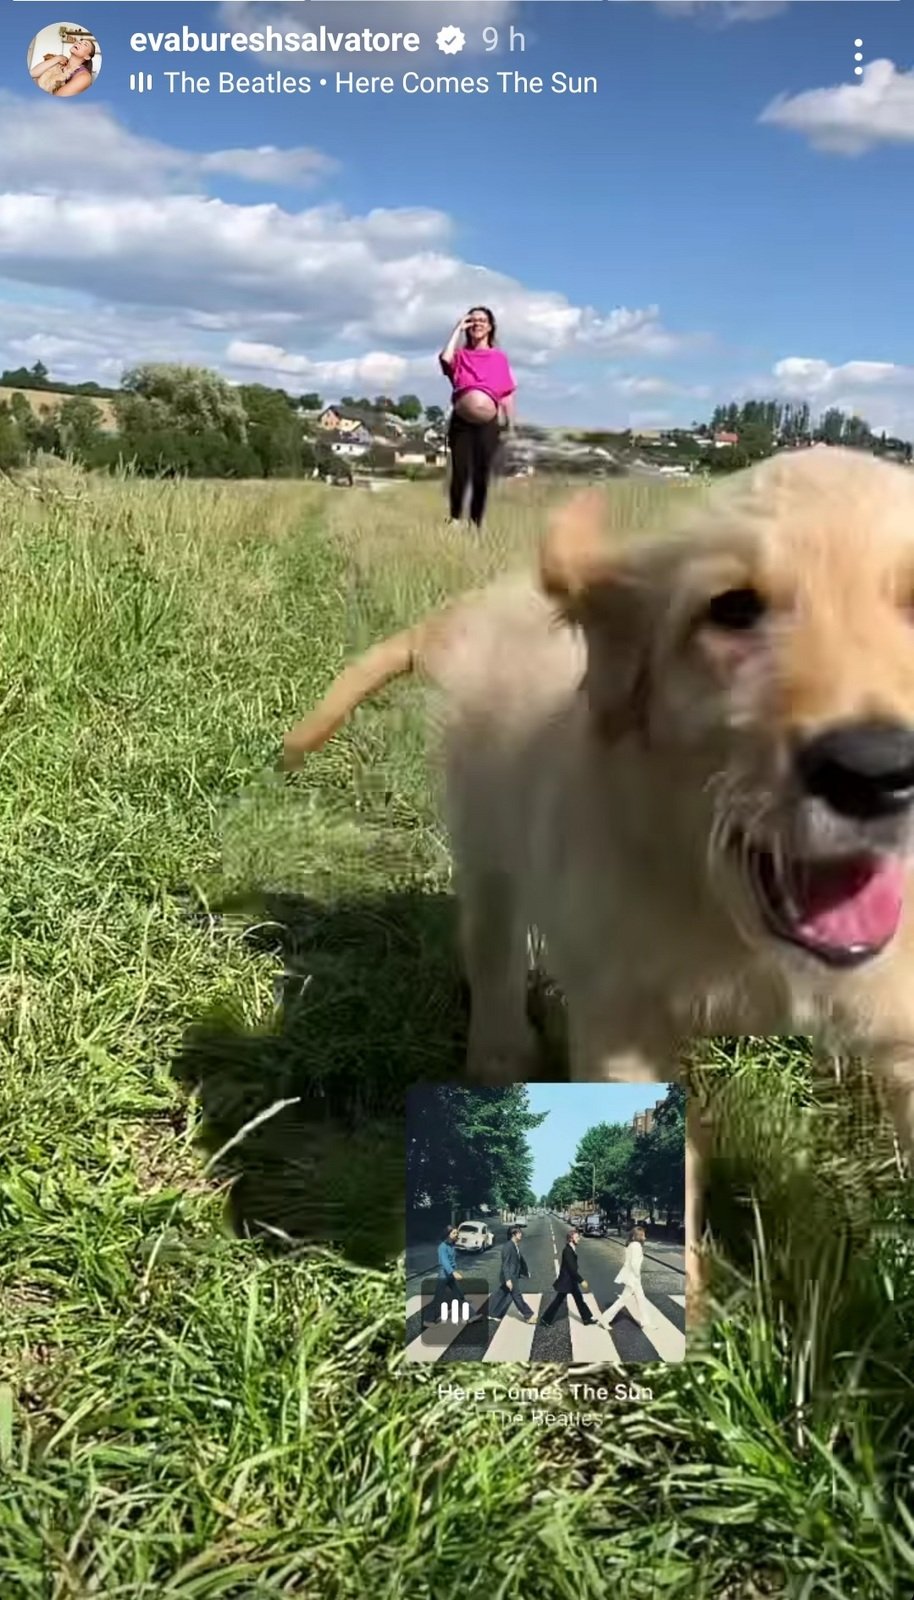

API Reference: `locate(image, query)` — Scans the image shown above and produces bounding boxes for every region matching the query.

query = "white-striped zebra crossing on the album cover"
[407,1291,685,1366]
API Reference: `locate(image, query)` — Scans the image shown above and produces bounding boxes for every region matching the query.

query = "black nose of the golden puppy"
[797,722,914,821]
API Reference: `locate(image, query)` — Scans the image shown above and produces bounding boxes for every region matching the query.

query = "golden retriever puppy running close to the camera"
[285,448,914,1312]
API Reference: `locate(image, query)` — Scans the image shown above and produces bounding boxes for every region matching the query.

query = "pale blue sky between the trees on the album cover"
[527,1083,669,1198]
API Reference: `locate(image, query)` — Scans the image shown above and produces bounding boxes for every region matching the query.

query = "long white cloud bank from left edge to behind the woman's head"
[0,178,691,374]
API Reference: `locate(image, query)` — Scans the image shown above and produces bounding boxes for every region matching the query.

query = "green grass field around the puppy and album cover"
[0,474,914,1600]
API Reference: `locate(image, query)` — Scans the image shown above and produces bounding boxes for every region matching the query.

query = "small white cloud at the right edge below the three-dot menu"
[759,61,914,155]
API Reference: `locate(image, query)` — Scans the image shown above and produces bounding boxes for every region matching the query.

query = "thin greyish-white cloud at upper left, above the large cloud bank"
[0,90,338,195]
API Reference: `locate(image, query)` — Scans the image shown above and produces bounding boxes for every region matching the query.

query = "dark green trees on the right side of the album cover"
[544,1083,685,1222]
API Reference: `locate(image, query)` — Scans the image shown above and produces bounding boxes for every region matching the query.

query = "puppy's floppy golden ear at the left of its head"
[539,490,656,738]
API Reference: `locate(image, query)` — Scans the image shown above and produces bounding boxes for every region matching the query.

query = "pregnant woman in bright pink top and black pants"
[439,306,517,528]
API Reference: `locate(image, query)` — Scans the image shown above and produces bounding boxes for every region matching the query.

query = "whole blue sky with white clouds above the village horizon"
[0,0,914,435]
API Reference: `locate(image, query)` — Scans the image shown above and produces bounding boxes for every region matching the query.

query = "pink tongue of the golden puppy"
[797,858,904,950]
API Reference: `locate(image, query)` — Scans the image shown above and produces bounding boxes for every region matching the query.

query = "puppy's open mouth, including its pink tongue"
[741,842,904,966]
